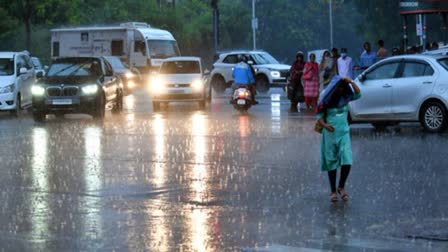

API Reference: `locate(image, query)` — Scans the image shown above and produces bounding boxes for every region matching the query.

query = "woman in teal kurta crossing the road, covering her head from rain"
[315,76,361,202]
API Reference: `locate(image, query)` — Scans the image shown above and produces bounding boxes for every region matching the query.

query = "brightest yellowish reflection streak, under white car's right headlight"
[190,113,209,252]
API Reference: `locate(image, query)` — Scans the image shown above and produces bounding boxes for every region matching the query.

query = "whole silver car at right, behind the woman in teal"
[350,55,448,132]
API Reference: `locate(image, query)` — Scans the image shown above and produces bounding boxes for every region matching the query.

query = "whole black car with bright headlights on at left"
[31,57,123,121]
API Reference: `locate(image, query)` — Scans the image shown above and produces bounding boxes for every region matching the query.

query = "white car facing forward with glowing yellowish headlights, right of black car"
[150,57,211,110]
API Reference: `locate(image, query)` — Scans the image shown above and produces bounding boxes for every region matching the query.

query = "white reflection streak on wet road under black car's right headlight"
[81,127,103,238]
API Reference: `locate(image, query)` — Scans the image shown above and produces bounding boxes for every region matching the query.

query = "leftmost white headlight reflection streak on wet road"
[31,128,50,244]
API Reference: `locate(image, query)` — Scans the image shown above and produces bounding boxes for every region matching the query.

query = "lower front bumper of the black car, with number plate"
[33,96,98,114]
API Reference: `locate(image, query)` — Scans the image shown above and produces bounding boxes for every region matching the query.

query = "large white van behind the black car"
[51,22,180,73]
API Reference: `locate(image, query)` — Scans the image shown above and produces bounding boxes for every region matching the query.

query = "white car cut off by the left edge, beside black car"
[0,52,36,115]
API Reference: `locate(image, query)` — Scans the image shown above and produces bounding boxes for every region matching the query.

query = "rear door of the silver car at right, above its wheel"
[392,59,436,120]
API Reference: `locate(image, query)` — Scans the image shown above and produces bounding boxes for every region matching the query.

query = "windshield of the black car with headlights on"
[47,59,102,77]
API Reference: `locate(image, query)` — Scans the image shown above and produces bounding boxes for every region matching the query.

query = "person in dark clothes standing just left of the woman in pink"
[288,51,305,112]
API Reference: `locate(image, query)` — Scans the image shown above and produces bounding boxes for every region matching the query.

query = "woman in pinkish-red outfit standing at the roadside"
[302,53,319,109]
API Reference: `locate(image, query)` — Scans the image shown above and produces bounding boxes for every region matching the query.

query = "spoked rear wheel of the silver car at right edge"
[420,102,447,133]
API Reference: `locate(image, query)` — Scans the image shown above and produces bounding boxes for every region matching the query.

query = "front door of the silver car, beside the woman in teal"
[350,61,401,120]
